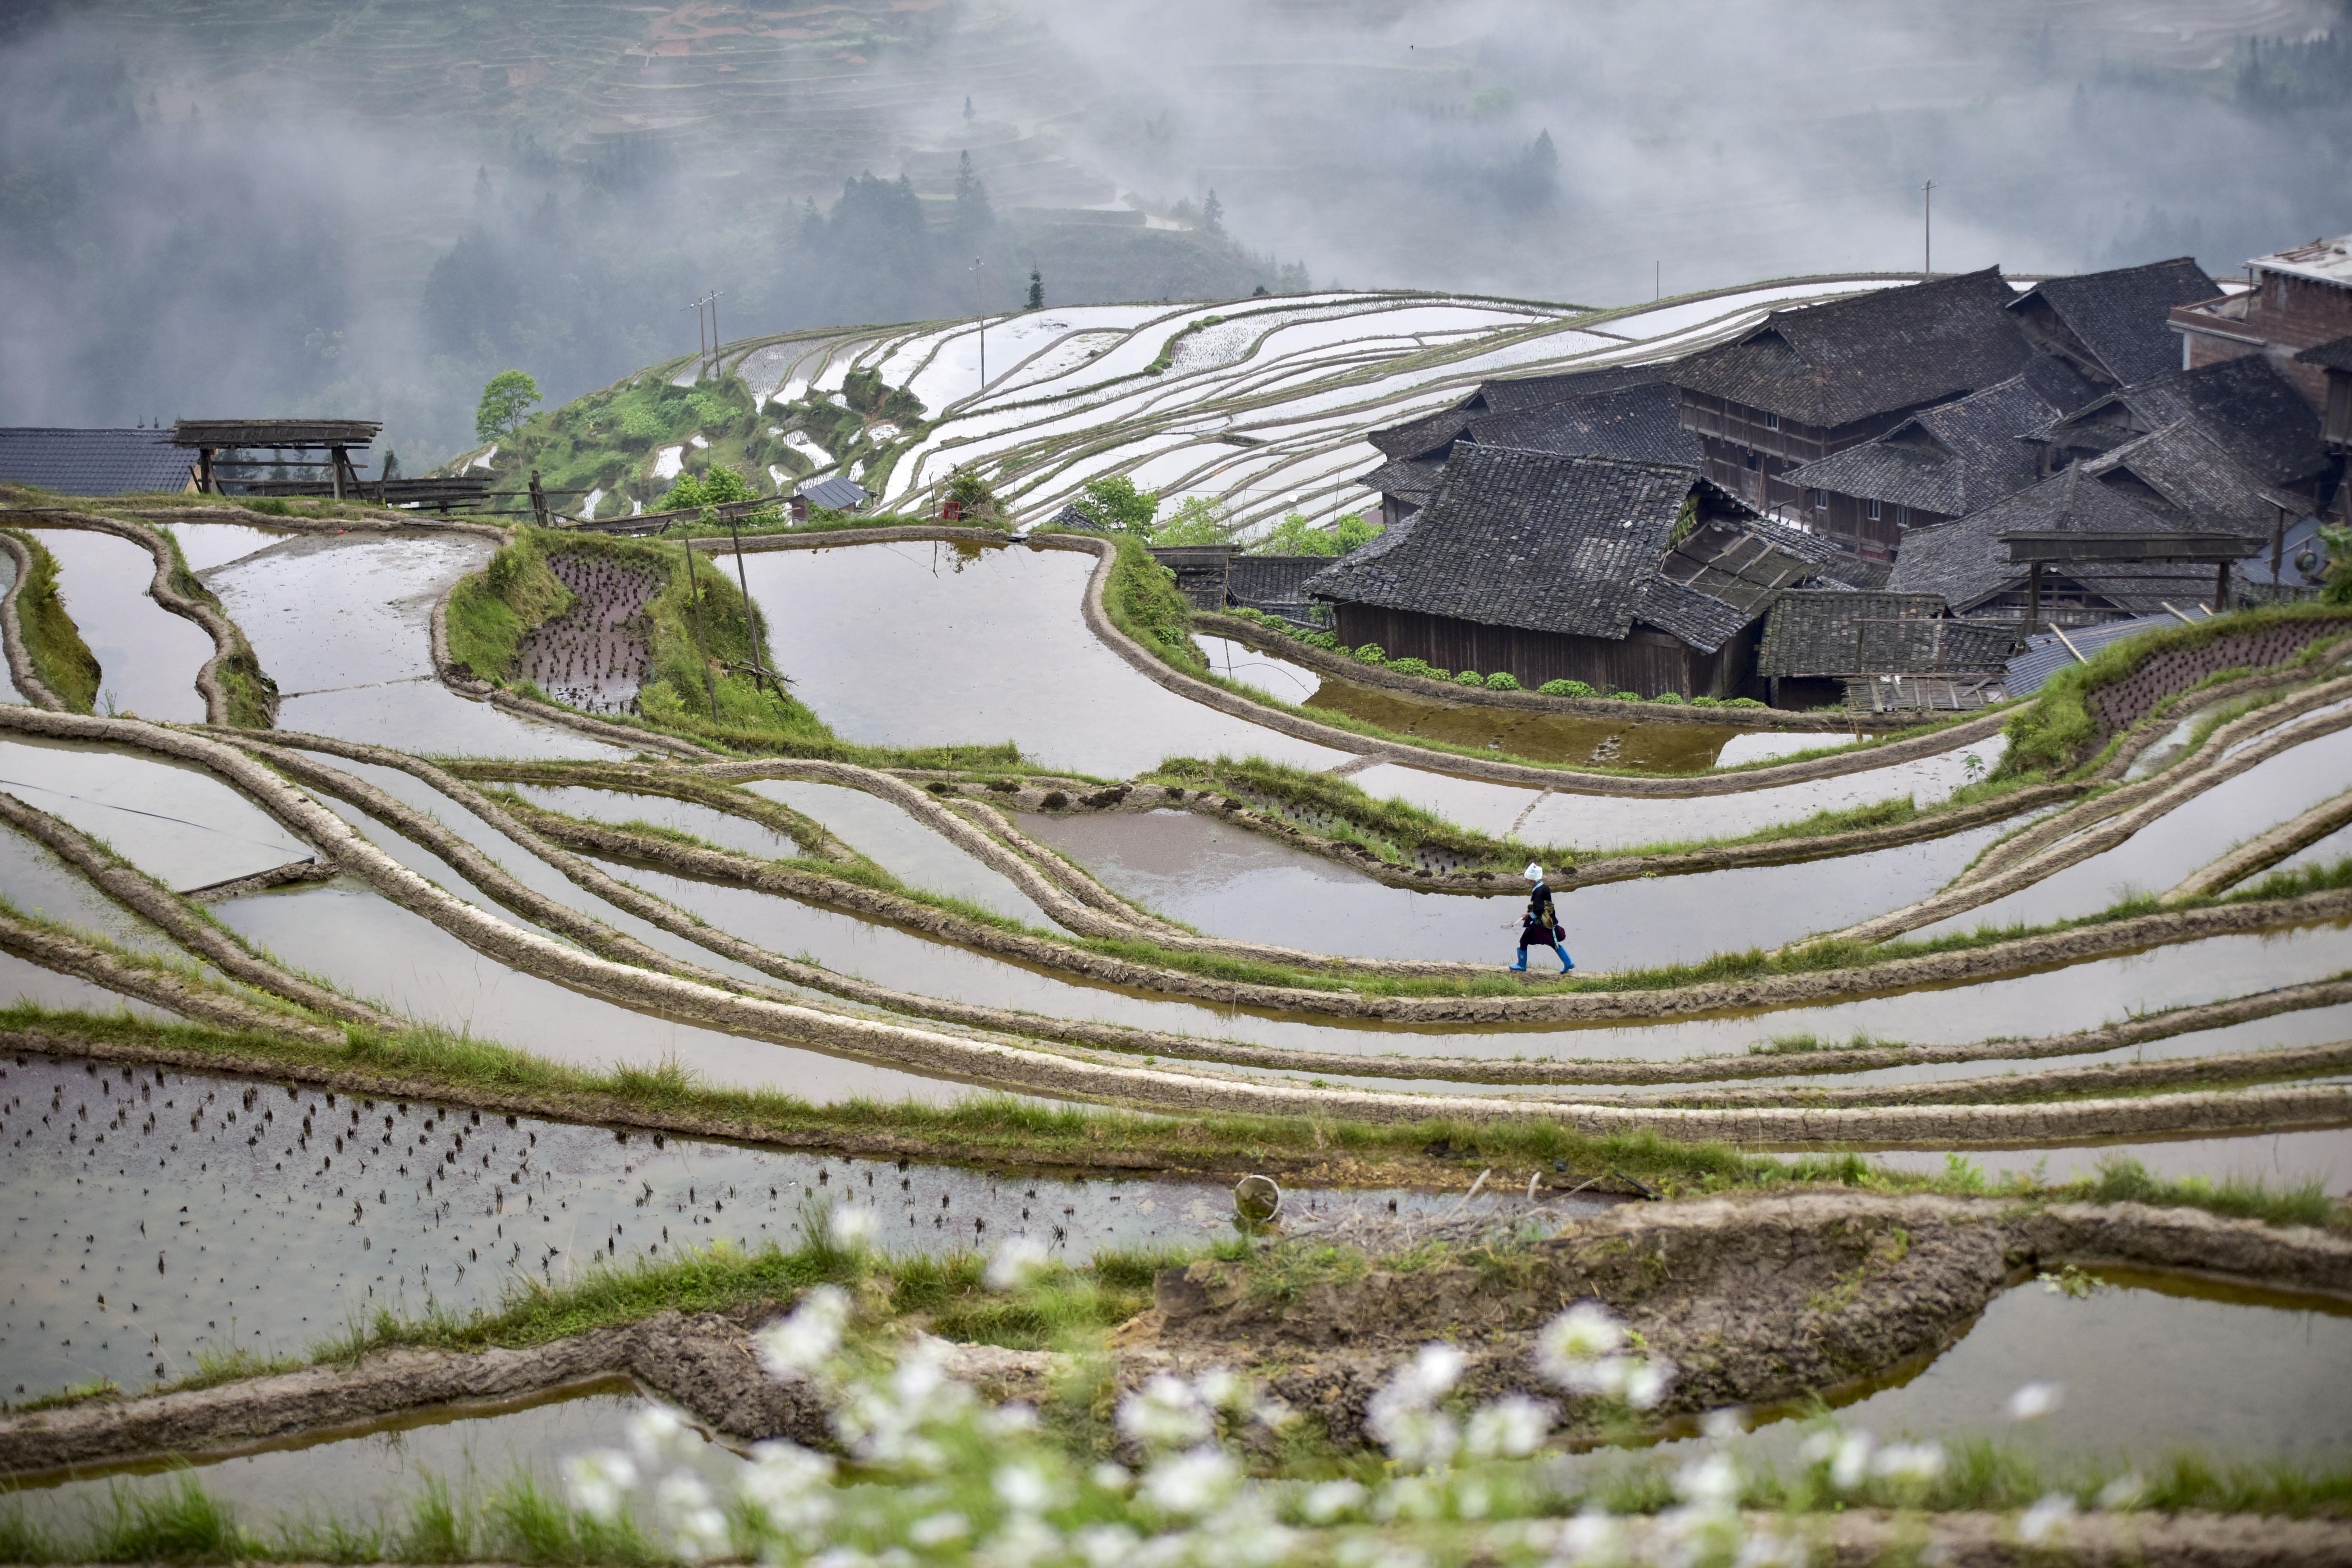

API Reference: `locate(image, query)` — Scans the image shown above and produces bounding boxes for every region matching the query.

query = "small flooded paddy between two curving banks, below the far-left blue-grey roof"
[35,529,212,724]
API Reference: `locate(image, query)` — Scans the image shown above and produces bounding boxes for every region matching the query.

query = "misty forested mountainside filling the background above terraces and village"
[0,0,2352,473]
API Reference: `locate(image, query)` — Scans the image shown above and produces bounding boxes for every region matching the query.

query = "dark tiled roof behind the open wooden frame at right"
[1886,465,2213,614]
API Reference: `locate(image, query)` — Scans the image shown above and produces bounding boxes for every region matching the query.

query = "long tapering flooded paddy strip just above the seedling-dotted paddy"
[219,879,971,1105]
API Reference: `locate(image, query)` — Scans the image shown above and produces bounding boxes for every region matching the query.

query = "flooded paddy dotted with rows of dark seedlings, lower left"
[0,1055,1580,1396]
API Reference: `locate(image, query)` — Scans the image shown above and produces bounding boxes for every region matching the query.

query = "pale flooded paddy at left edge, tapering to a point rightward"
[0,736,311,889]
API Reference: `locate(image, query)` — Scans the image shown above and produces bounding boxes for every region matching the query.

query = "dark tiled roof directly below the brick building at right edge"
[2039,355,2329,484]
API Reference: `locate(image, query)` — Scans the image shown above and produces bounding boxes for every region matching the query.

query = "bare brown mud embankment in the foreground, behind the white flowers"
[0,1190,2352,1472]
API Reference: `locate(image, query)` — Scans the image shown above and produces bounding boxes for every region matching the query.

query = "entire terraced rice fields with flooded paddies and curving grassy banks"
[0,291,2352,1561]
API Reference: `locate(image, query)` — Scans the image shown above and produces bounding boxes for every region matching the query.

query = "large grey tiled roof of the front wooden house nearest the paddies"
[1306,447,1698,637]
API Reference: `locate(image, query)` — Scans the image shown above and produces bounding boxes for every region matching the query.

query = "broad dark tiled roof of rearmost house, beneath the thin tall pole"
[1668,268,2035,428]
